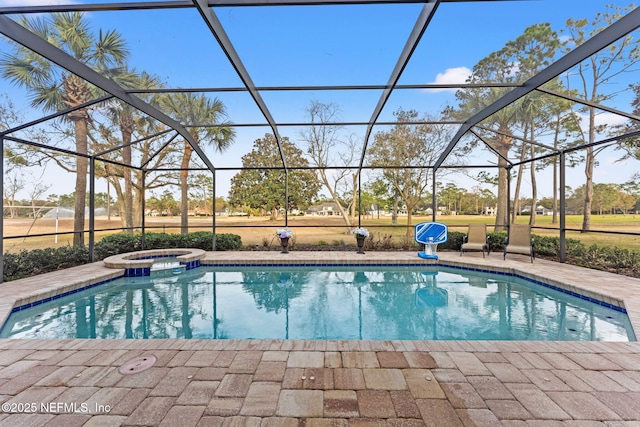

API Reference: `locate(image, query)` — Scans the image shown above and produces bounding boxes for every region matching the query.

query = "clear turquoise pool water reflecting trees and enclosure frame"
[0,265,635,341]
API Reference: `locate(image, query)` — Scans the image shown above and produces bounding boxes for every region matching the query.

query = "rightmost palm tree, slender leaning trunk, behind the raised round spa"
[161,92,235,234]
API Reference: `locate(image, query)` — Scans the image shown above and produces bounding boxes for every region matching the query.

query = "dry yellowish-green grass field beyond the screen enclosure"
[3,215,640,251]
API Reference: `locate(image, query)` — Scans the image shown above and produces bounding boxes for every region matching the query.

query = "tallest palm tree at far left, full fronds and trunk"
[0,12,128,245]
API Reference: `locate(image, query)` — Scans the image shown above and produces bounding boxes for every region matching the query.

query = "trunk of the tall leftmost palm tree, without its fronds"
[73,118,89,246]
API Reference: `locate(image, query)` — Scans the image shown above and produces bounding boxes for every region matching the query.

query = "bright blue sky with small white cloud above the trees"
[0,0,640,201]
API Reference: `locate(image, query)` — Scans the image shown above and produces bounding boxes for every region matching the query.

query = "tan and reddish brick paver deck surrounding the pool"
[0,252,640,427]
